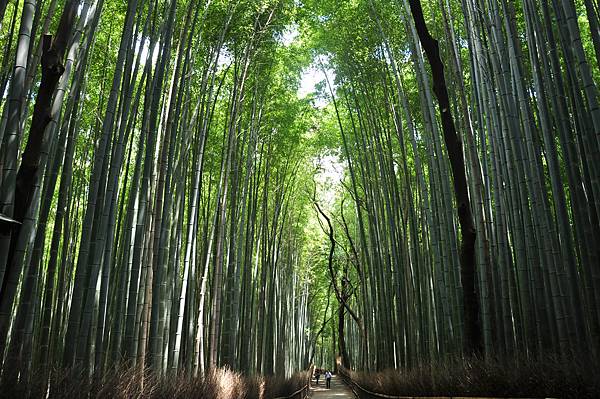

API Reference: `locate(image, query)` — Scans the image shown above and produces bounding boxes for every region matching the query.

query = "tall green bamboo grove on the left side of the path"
[0,0,318,382]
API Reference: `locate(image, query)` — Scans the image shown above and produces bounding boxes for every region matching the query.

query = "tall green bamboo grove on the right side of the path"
[304,0,600,370]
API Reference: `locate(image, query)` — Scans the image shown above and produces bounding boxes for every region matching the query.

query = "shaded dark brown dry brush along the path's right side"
[342,357,600,399]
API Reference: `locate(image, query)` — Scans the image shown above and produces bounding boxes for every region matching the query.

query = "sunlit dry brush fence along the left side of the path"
[0,368,308,399]
